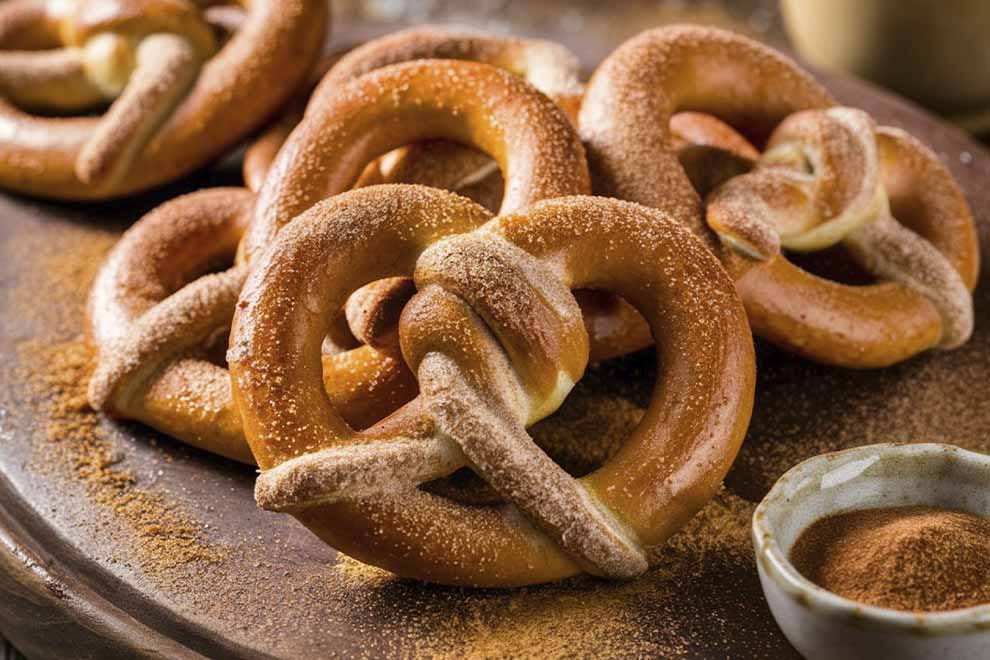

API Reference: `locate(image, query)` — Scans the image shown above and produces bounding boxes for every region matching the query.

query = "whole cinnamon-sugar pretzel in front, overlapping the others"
[228,183,754,586]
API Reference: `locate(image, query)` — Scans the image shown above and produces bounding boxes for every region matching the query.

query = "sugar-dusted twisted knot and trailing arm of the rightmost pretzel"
[707,107,973,349]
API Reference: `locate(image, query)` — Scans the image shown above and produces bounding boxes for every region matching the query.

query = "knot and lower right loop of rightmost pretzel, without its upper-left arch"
[707,107,978,366]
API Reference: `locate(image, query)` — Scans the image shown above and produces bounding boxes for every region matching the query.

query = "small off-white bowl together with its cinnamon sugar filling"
[752,444,990,660]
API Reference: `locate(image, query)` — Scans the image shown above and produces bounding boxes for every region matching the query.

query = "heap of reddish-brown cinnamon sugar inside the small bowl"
[791,506,990,612]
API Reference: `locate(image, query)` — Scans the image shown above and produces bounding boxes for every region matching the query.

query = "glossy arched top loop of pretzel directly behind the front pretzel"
[243,60,590,258]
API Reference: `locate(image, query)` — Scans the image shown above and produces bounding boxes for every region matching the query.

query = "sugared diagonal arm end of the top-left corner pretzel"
[76,34,201,185]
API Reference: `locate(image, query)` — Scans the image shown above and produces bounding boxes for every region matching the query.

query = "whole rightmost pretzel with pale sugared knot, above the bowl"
[579,26,978,367]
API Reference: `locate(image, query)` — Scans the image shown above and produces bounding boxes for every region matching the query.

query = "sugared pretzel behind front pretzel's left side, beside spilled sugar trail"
[89,188,422,463]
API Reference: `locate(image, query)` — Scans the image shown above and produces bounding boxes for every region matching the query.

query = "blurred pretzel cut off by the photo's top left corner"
[0,0,328,200]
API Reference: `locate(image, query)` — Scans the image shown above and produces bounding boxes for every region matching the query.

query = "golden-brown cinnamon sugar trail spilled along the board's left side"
[4,222,226,574]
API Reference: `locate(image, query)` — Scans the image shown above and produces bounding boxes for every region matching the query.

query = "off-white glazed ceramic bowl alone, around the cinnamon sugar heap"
[753,444,990,660]
